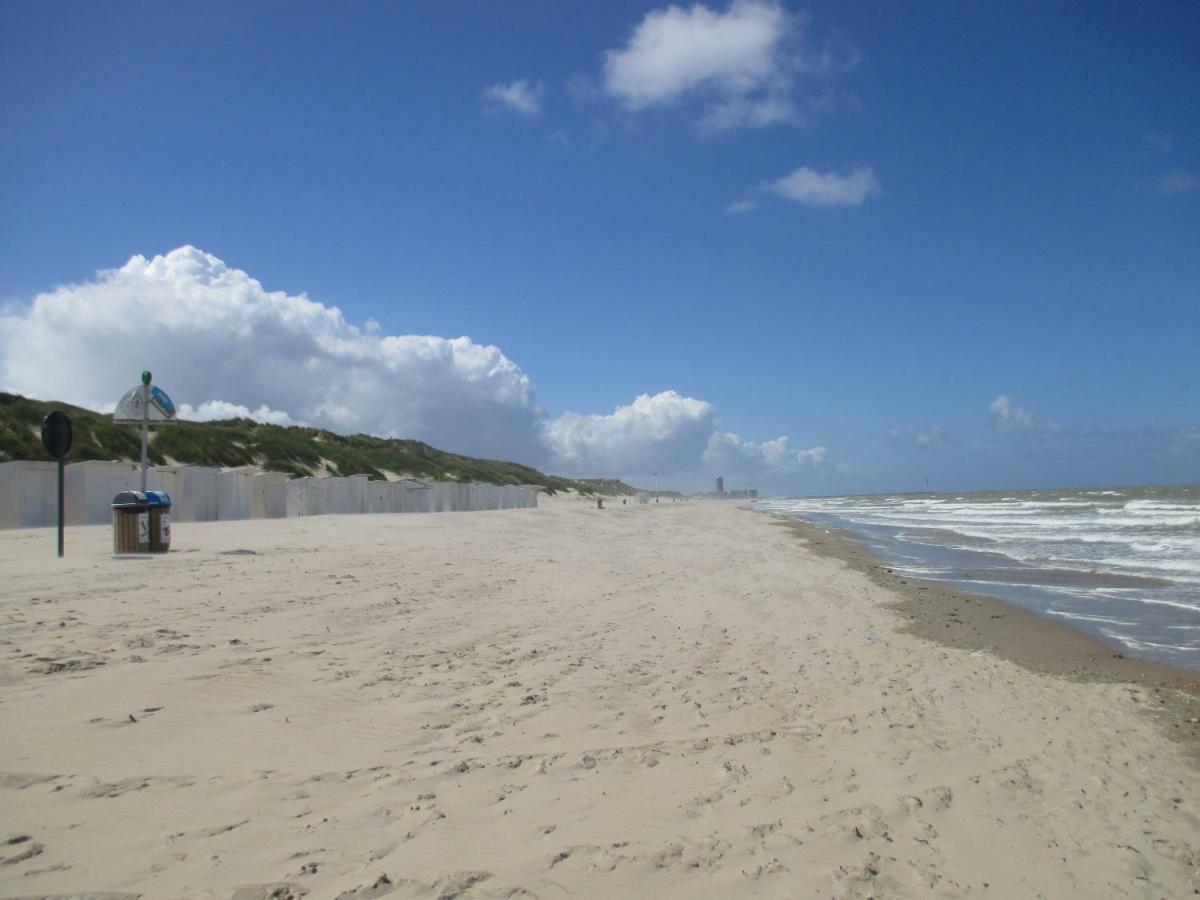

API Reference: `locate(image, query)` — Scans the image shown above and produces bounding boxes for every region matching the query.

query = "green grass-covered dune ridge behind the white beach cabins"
[0,394,604,493]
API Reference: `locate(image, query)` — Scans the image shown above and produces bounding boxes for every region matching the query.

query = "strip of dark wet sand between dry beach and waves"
[748,508,1200,760]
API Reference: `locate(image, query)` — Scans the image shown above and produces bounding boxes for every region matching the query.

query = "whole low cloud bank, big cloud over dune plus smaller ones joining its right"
[0,247,824,475]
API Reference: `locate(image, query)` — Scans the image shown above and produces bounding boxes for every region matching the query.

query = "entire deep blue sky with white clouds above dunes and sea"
[0,0,1200,494]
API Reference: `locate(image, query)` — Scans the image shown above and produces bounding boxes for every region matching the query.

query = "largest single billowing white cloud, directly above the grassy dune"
[0,246,542,458]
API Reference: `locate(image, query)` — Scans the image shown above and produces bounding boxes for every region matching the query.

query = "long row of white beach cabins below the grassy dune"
[0,461,540,528]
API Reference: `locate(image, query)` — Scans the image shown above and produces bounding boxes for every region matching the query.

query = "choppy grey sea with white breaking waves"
[755,485,1200,668]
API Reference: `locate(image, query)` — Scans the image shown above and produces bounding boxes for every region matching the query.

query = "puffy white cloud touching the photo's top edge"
[604,0,857,131]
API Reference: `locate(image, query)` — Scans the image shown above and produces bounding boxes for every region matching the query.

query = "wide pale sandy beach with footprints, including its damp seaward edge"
[0,497,1200,900]
